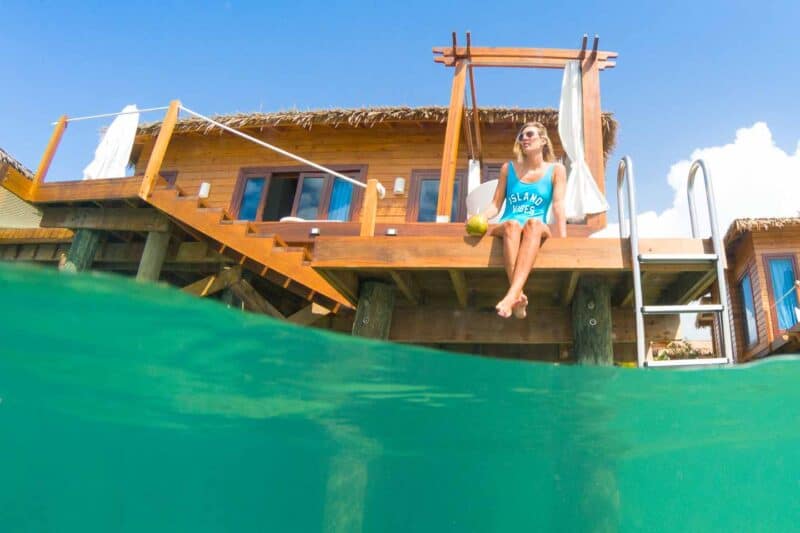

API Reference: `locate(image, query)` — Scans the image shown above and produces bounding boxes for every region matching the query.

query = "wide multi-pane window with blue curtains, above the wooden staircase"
[231,167,365,222]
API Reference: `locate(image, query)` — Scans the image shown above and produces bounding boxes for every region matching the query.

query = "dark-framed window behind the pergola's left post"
[406,170,467,222]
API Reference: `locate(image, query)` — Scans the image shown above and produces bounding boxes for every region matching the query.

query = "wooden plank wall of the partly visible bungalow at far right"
[728,227,800,361]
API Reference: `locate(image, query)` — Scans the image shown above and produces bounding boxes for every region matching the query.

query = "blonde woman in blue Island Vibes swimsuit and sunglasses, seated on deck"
[482,122,567,318]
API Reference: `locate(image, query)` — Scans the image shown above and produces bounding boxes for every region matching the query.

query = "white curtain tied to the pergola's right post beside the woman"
[558,61,608,222]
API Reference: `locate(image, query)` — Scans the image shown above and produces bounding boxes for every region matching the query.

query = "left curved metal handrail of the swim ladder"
[617,155,645,368]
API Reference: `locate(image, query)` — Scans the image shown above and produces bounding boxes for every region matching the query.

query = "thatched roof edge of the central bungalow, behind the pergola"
[138,106,617,156]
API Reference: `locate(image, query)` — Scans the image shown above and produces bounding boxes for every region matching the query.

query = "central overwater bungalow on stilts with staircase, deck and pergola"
[0,38,740,366]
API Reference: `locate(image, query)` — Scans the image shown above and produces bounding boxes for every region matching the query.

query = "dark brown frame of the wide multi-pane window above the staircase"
[228,165,367,223]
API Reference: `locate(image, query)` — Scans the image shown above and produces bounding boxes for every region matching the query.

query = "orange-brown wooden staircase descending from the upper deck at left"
[143,186,352,312]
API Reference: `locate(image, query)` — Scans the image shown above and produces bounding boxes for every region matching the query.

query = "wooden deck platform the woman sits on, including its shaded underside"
[311,236,714,309]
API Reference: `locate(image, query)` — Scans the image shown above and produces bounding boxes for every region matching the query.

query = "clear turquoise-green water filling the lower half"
[0,265,800,533]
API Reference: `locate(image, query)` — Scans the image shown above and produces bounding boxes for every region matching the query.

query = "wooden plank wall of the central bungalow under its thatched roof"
[137,123,563,223]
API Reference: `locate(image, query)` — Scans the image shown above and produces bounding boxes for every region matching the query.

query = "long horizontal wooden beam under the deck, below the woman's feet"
[389,303,680,344]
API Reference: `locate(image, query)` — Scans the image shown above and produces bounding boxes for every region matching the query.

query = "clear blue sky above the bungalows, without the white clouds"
[0,0,800,220]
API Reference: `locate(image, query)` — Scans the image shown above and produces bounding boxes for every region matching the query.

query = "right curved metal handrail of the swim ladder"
[686,159,735,363]
